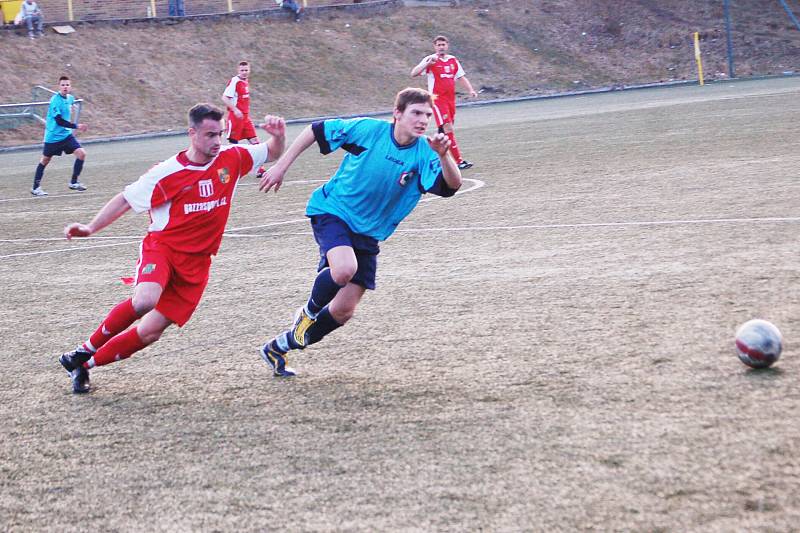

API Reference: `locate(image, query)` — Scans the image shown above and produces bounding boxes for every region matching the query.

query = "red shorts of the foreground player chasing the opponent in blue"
[134,238,211,326]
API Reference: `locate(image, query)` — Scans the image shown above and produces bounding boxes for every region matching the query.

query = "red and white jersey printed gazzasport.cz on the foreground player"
[122,143,269,255]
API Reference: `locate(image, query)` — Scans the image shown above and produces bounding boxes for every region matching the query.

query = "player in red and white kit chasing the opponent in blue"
[59,104,286,393]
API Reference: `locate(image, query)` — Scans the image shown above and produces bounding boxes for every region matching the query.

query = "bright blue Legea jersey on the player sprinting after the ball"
[306,118,456,241]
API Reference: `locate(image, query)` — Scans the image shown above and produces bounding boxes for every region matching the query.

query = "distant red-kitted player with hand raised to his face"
[411,35,478,170]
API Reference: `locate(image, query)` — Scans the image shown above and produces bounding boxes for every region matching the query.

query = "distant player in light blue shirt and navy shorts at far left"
[31,76,87,196]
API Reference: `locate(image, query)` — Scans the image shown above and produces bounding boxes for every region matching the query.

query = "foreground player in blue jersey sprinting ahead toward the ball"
[259,88,461,377]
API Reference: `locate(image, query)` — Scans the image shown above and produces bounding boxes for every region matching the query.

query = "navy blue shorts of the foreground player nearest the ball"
[310,214,381,290]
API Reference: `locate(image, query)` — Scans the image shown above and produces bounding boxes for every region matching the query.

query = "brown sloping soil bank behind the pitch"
[0,0,800,145]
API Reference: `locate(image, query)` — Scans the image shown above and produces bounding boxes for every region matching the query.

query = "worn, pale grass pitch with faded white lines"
[0,78,800,531]
